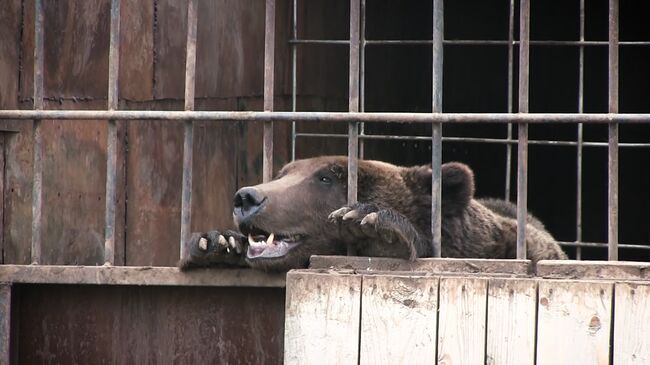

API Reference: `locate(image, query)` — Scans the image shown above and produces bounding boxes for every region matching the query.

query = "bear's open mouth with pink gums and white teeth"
[246,229,304,259]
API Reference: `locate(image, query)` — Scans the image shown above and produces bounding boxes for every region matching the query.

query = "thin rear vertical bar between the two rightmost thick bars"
[576,0,585,260]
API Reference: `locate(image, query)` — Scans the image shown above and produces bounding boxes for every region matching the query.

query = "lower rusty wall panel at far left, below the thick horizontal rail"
[5,114,124,264]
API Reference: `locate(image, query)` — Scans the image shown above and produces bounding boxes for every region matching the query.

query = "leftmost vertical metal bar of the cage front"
[31,0,43,264]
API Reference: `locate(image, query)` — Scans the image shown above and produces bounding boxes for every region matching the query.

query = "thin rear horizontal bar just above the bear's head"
[296,133,650,148]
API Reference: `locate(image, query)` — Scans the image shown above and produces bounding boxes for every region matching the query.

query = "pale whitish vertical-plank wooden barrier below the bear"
[285,258,650,365]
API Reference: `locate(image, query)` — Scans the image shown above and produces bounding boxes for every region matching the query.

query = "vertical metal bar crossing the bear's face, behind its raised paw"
[348,0,361,255]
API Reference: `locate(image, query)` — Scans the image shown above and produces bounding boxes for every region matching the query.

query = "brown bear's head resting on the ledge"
[233,156,474,271]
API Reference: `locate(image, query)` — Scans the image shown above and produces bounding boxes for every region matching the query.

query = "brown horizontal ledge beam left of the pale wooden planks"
[0,265,285,287]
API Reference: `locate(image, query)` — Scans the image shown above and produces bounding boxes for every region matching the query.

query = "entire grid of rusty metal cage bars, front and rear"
[0,0,650,265]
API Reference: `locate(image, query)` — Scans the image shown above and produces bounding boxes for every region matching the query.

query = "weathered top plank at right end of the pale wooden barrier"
[536,260,650,280]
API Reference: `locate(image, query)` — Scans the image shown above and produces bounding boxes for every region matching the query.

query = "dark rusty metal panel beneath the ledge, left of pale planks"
[15,285,284,364]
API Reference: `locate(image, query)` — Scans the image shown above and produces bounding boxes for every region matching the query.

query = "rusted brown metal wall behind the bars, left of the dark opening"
[0,0,334,265]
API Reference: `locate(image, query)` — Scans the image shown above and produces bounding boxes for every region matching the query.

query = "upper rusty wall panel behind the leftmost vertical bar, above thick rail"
[21,0,110,99]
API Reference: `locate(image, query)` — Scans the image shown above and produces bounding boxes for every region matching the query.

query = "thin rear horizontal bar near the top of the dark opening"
[289,39,650,47]
